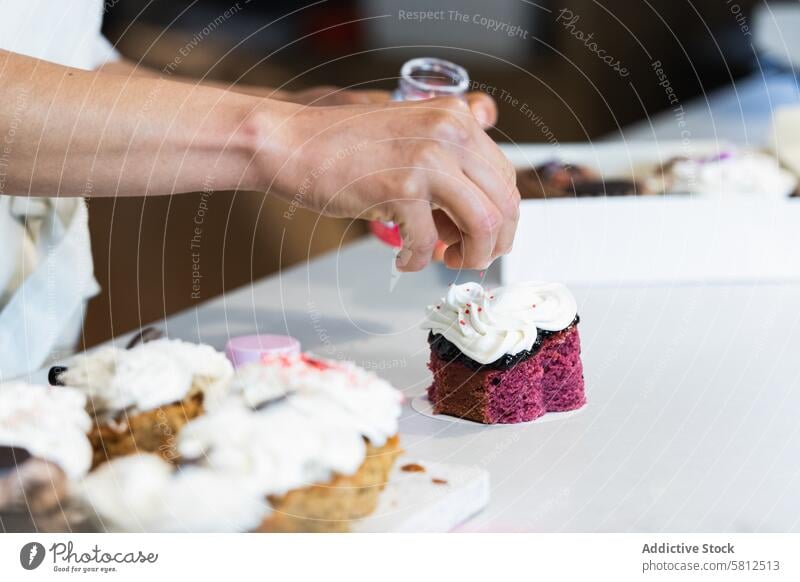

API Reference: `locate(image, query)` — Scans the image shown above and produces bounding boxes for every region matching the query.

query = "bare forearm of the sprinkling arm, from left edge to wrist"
[0,51,289,196]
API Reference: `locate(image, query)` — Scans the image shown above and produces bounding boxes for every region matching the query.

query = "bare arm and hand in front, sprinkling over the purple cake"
[0,51,519,270]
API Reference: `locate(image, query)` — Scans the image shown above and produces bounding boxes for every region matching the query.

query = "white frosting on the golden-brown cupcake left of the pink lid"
[60,339,233,413]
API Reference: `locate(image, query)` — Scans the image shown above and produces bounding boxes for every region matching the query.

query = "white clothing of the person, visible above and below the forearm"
[0,0,118,380]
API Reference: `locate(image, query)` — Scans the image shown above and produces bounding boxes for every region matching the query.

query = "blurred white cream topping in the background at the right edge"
[664,152,797,197]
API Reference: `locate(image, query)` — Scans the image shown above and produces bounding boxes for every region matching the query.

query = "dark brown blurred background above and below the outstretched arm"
[84,0,764,346]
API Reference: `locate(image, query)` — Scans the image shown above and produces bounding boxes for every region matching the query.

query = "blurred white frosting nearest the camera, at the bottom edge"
[73,455,269,532]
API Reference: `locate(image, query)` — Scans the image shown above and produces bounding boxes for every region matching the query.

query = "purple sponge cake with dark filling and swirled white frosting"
[423,283,586,424]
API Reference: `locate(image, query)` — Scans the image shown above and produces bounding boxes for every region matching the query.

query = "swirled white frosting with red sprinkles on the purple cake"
[422,282,578,364]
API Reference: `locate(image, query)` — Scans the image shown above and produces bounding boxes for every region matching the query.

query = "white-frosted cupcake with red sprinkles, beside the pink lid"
[178,354,402,532]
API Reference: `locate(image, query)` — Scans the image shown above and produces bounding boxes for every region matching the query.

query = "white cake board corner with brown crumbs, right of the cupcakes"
[352,455,490,533]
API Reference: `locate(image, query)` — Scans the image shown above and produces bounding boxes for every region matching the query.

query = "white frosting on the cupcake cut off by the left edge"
[0,382,92,479]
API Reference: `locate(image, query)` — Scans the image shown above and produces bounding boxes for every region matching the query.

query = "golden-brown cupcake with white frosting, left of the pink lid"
[57,339,233,467]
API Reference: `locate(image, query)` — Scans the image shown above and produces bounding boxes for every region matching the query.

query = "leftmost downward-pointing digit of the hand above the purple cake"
[394,200,439,271]
